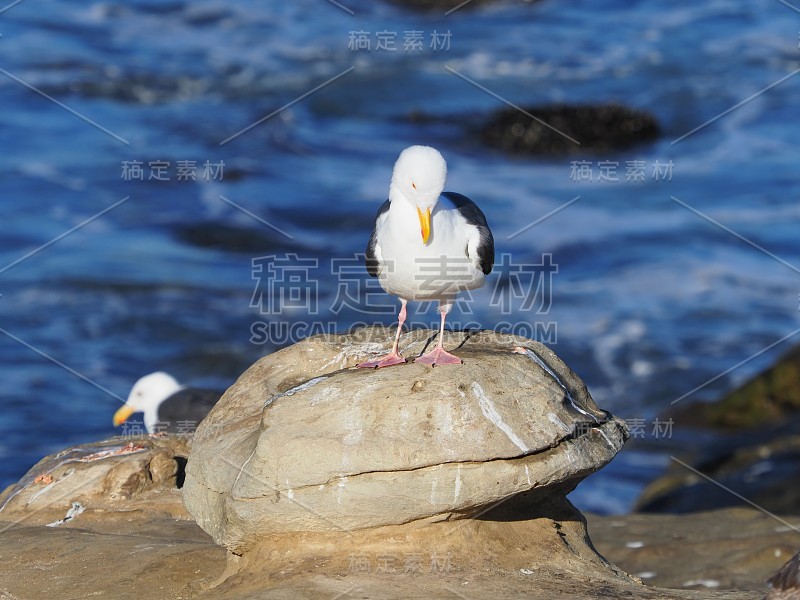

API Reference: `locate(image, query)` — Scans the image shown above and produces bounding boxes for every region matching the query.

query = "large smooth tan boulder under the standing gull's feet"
[184,328,627,554]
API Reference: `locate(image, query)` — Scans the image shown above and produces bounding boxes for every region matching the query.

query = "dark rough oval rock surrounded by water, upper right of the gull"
[480,104,660,156]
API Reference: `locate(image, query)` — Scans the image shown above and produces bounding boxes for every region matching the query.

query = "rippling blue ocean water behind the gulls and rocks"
[0,0,800,512]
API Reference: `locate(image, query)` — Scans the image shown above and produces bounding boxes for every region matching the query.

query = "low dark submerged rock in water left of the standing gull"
[174,222,302,254]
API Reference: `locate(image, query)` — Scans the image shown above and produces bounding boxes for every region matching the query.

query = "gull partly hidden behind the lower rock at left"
[114,371,222,434]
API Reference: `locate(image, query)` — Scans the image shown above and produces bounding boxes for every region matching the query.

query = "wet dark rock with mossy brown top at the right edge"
[637,348,800,514]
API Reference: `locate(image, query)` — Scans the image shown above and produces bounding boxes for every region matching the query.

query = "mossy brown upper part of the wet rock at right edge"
[672,346,800,429]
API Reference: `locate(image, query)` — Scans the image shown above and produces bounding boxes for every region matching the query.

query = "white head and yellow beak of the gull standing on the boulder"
[390,146,447,244]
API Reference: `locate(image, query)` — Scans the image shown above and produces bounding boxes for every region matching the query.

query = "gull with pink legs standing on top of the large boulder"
[358,146,494,368]
